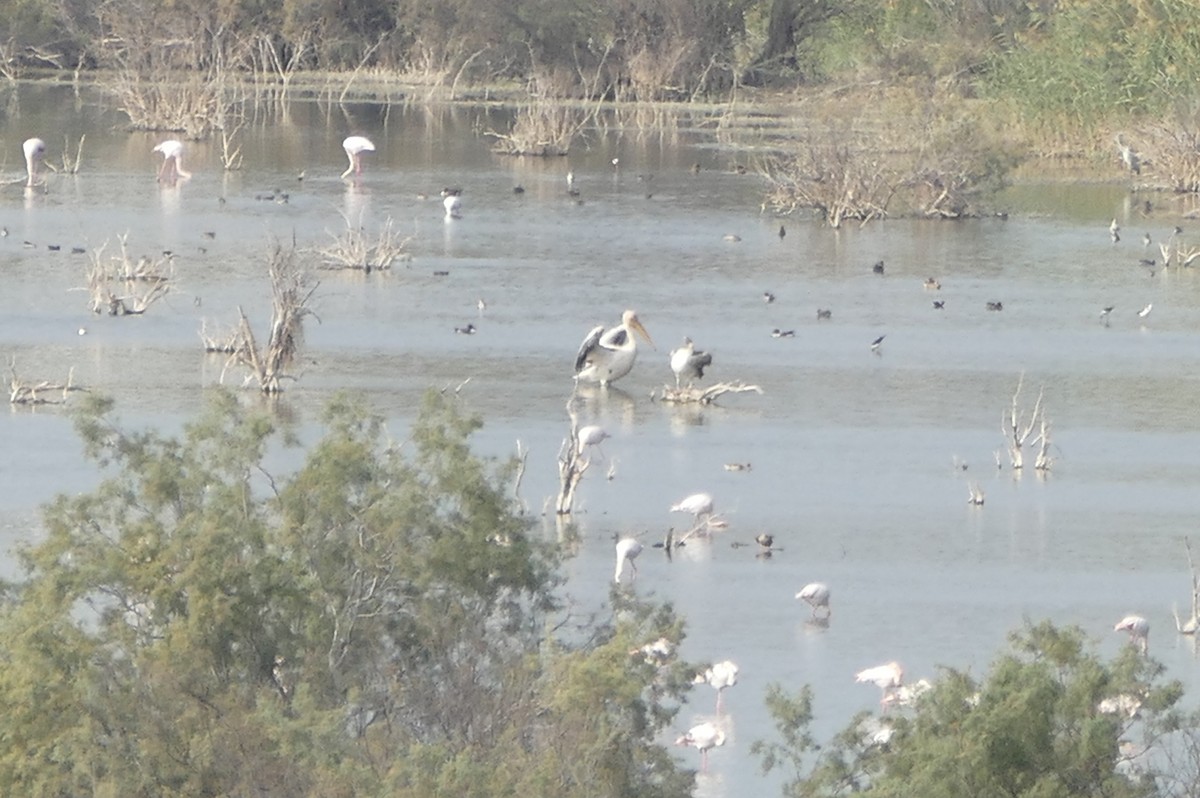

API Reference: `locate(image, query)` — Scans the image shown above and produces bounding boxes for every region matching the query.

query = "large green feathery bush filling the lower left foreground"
[0,391,691,798]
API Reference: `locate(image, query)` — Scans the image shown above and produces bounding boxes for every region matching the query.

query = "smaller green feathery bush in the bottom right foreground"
[754,623,1200,798]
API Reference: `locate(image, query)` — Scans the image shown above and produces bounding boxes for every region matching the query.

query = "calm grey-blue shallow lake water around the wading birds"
[0,81,1200,796]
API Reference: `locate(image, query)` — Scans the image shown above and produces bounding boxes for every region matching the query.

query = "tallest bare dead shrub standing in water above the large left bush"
[221,242,319,394]
